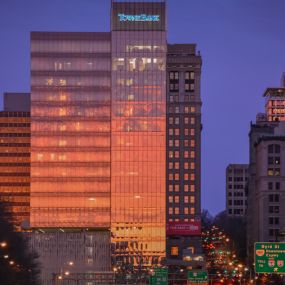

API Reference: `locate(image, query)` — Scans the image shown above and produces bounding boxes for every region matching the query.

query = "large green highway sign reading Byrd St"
[254,242,285,274]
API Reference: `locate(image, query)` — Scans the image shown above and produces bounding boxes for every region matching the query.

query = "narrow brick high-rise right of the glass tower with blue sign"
[166,44,202,267]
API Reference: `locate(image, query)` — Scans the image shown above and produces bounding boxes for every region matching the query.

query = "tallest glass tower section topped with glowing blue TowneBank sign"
[111,1,166,266]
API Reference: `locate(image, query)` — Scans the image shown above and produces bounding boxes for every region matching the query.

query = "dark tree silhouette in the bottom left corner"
[0,202,40,285]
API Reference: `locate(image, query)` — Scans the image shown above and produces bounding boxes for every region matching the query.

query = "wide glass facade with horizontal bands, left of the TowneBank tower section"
[31,32,110,228]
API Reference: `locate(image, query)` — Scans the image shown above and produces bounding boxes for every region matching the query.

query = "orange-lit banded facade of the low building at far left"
[0,111,30,227]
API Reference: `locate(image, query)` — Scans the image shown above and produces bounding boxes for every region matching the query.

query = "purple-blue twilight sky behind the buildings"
[0,0,285,214]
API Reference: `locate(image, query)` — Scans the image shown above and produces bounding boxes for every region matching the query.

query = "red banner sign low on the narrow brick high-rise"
[166,221,201,236]
